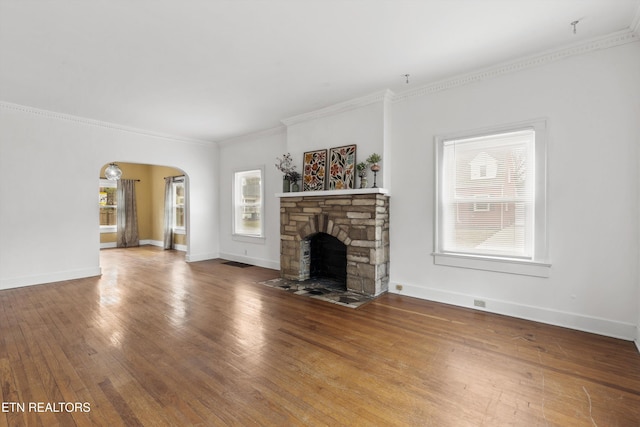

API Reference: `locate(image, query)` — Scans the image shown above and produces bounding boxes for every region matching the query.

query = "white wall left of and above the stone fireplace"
[219,98,388,269]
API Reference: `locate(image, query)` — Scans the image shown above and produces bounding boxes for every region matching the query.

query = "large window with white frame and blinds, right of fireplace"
[434,121,548,276]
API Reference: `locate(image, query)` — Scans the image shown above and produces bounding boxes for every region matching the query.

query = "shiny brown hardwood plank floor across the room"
[0,247,640,427]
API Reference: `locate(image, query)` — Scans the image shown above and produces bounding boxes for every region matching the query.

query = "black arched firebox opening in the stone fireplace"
[310,233,347,286]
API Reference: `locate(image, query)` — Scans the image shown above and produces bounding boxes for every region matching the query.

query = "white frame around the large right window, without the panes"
[432,119,551,277]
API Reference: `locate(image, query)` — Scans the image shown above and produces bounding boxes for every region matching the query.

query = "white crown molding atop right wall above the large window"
[393,29,640,102]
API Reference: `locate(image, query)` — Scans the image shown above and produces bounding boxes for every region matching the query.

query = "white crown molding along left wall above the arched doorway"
[0,101,213,145]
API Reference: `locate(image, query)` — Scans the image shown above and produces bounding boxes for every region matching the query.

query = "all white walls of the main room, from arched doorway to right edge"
[0,37,640,341]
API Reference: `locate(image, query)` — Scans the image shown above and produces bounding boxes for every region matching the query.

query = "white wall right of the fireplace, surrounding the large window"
[390,42,640,339]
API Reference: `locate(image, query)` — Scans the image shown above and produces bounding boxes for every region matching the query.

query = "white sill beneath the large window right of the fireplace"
[432,253,551,277]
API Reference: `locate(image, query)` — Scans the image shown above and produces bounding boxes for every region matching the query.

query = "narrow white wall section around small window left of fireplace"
[215,127,287,269]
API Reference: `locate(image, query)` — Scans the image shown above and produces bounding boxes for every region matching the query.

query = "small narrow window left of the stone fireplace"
[233,168,264,237]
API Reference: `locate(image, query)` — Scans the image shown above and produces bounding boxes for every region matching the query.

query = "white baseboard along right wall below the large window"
[389,283,640,342]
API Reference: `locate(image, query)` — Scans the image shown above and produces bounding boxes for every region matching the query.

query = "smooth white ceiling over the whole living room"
[0,0,640,141]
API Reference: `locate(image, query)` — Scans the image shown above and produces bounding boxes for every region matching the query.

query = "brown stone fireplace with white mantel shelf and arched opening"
[278,188,389,296]
